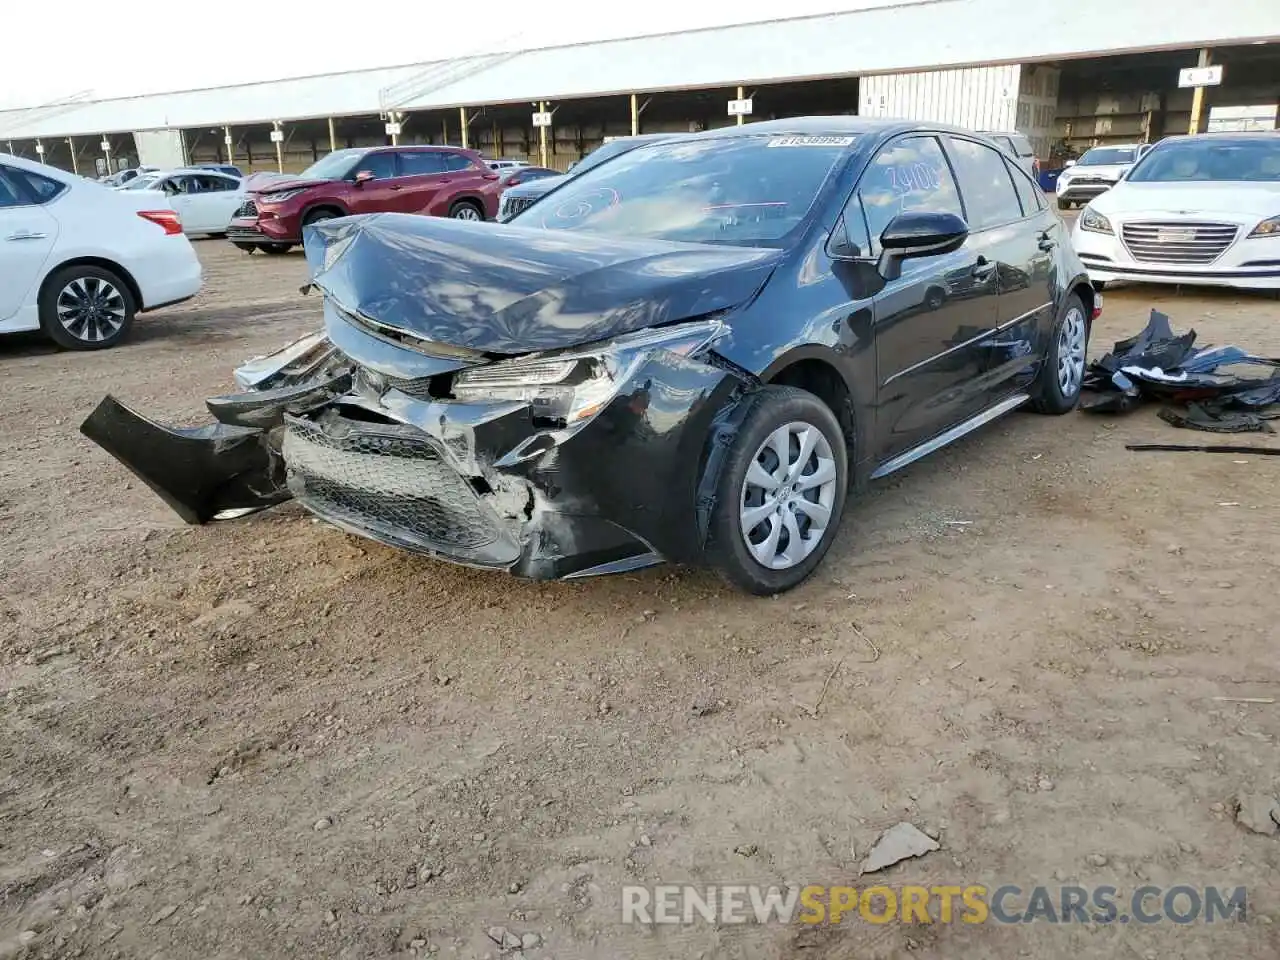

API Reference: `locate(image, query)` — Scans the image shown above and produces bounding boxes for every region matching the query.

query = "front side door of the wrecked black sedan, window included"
[845,134,997,460]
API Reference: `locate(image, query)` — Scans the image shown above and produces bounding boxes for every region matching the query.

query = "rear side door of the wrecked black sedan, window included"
[945,134,1065,399]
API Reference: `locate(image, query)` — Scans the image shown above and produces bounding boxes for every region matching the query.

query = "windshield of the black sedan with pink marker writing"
[513,136,854,246]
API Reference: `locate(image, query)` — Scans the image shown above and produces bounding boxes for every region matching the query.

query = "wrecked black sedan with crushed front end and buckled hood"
[82,116,1101,594]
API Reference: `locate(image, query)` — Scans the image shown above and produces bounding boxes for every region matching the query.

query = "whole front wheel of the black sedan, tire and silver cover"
[705,387,849,596]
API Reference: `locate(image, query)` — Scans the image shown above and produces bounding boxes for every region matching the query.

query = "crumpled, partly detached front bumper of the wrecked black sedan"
[82,320,749,580]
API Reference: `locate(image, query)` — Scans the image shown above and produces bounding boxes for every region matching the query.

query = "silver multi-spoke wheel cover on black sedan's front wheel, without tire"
[739,421,837,570]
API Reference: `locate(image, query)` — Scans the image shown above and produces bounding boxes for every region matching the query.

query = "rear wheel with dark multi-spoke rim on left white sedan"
[40,264,138,349]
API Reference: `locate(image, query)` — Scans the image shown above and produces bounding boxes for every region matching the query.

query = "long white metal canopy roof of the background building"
[0,0,1280,140]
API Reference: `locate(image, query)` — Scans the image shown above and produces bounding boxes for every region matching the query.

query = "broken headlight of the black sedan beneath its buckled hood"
[453,320,726,426]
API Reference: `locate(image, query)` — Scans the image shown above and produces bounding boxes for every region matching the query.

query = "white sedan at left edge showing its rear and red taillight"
[0,154,202,349]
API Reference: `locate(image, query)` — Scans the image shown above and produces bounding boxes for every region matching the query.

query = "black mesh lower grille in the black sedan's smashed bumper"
[283,417,498,556]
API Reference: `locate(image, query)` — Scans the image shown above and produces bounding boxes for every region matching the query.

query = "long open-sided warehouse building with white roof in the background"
[0,0,1280,175]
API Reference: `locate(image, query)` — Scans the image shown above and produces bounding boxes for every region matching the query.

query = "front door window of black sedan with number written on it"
[849,137,962,252]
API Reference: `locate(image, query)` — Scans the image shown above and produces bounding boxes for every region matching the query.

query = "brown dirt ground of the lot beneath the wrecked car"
[0,232,1280,960]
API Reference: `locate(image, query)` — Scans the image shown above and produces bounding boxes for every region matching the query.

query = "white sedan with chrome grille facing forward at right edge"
[1071,132,1280,289]
